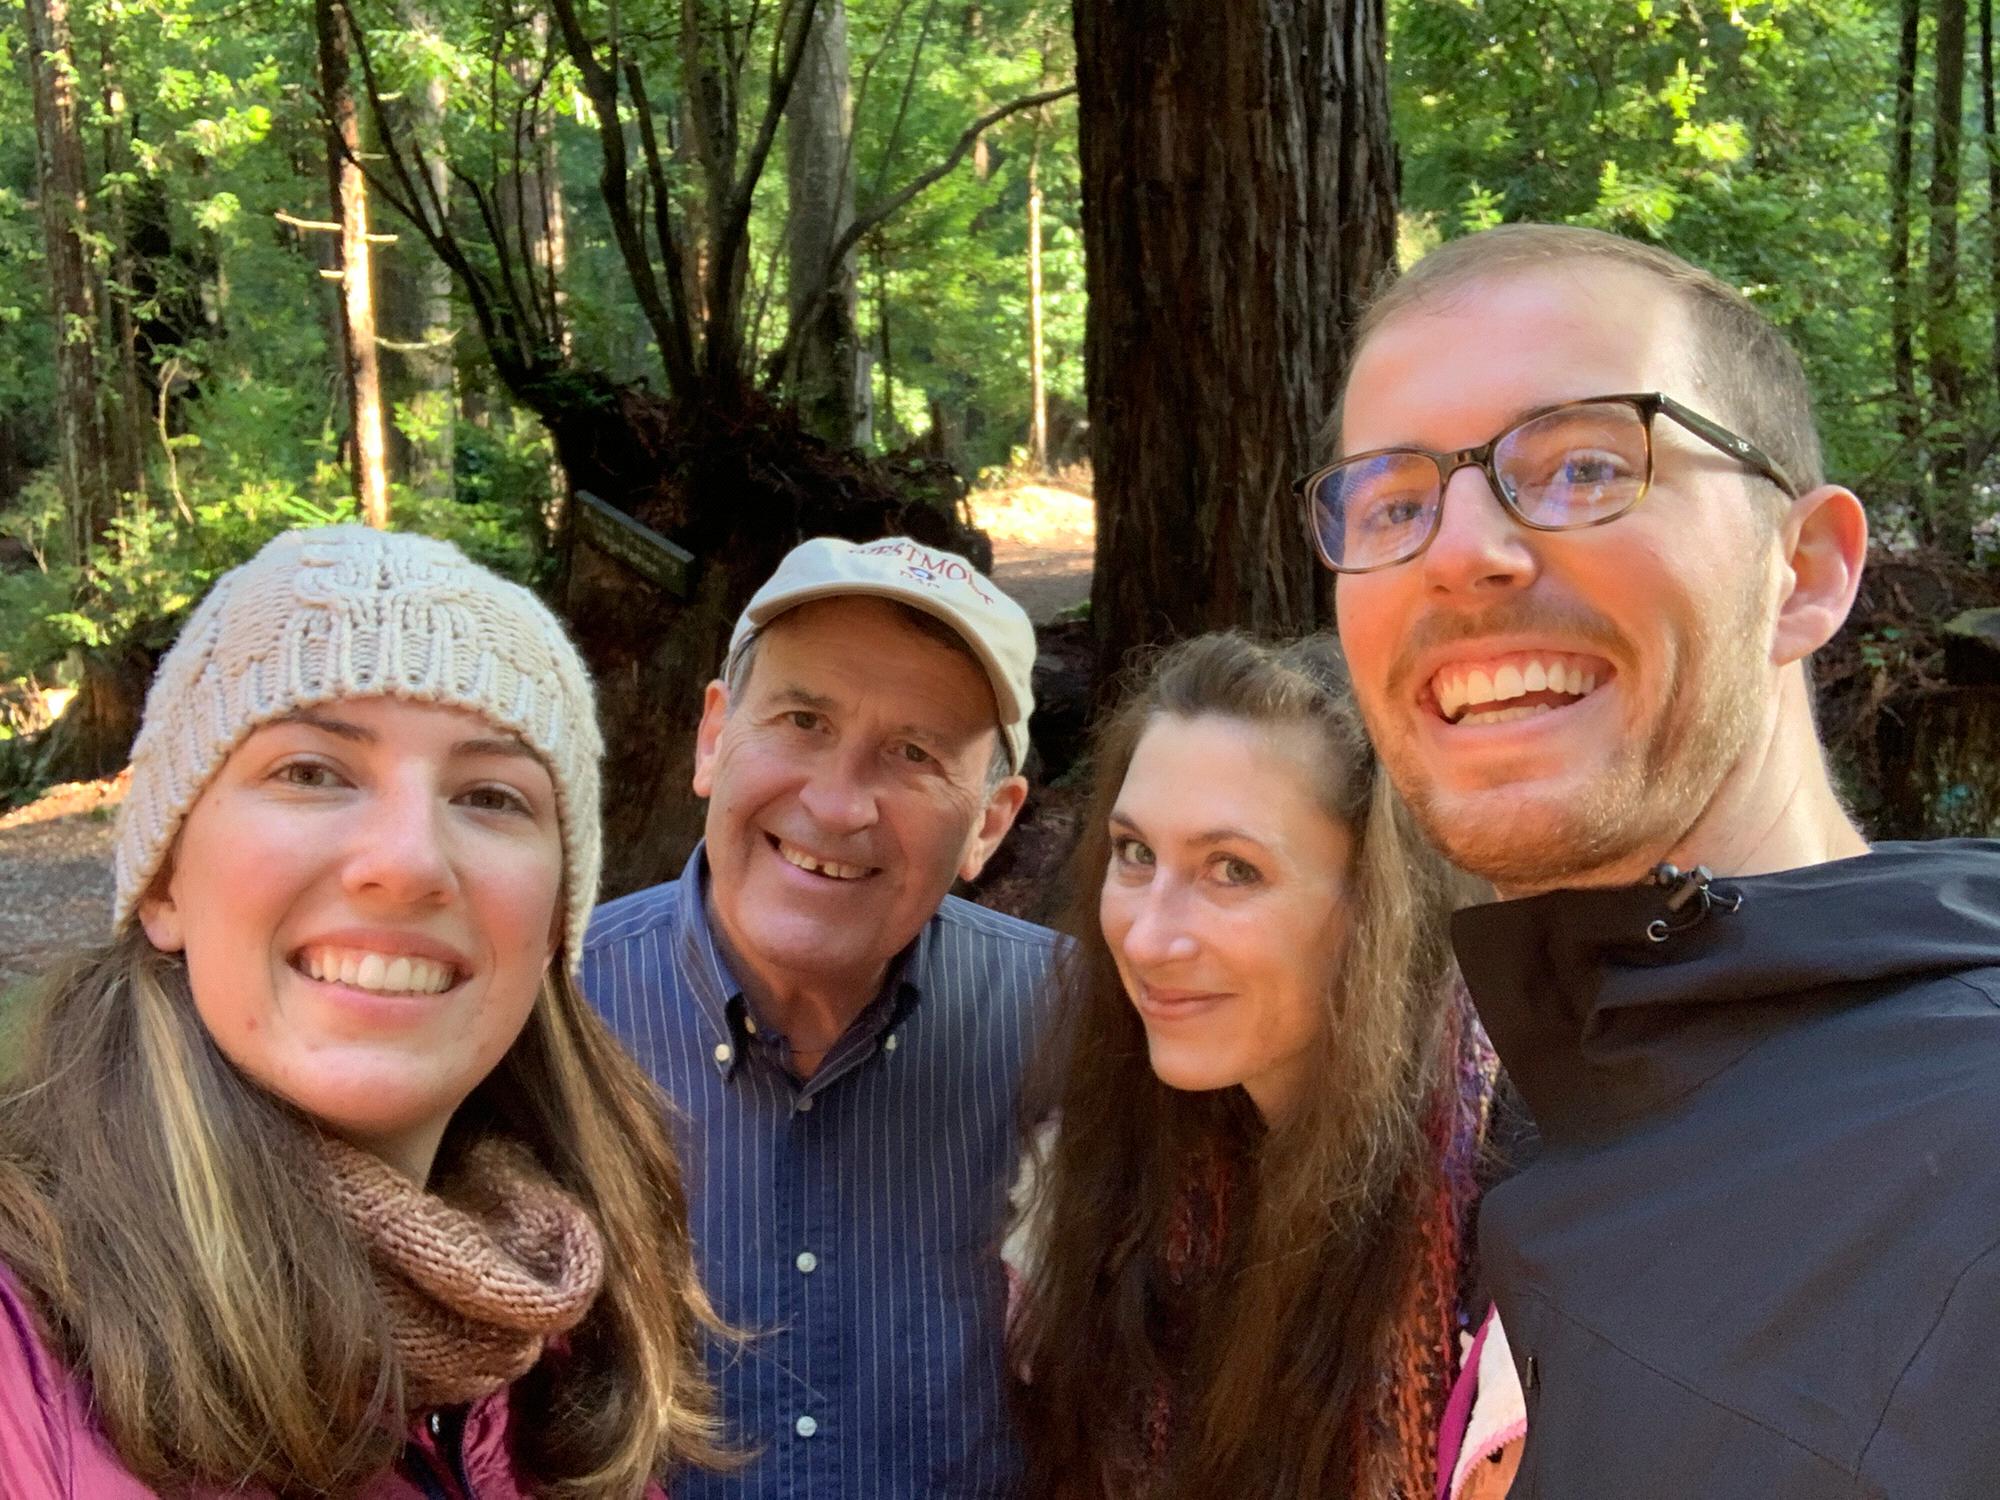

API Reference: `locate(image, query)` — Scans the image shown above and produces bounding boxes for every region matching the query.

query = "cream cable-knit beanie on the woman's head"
[112,526,604,972]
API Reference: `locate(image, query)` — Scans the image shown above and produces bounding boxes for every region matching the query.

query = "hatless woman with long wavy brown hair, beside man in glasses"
[1014,634,1494,1500]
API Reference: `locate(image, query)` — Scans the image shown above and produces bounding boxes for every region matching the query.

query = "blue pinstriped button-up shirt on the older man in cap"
[584,850,1054,1500]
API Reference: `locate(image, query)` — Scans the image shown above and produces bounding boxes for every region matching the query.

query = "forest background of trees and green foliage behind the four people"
[0,0,2000,928]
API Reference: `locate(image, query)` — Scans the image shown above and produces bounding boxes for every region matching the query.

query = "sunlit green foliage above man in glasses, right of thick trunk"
[1392,0,2000,532]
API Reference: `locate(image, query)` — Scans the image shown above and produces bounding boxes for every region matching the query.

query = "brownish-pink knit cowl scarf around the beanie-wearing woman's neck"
[320,1136,604,1406]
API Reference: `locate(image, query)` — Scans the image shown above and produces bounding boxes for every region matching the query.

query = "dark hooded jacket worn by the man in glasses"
[1452,840,2000,1500]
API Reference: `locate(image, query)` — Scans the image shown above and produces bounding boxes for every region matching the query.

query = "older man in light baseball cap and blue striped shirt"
[584,538,1052,1500]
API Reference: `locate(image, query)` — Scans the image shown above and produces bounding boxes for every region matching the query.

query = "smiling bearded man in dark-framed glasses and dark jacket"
[1300,226,2000,1500]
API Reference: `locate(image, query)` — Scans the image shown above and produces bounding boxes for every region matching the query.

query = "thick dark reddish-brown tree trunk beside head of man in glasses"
[1076,0,1396,692]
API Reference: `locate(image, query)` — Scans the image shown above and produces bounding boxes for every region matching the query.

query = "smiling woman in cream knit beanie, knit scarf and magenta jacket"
[0,526,720,1500]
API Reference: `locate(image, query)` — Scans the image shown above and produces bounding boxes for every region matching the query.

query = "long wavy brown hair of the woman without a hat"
[1012,634,1454,1500]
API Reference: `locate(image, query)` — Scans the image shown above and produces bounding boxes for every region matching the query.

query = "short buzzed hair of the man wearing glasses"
[1328,224,1824,492]
